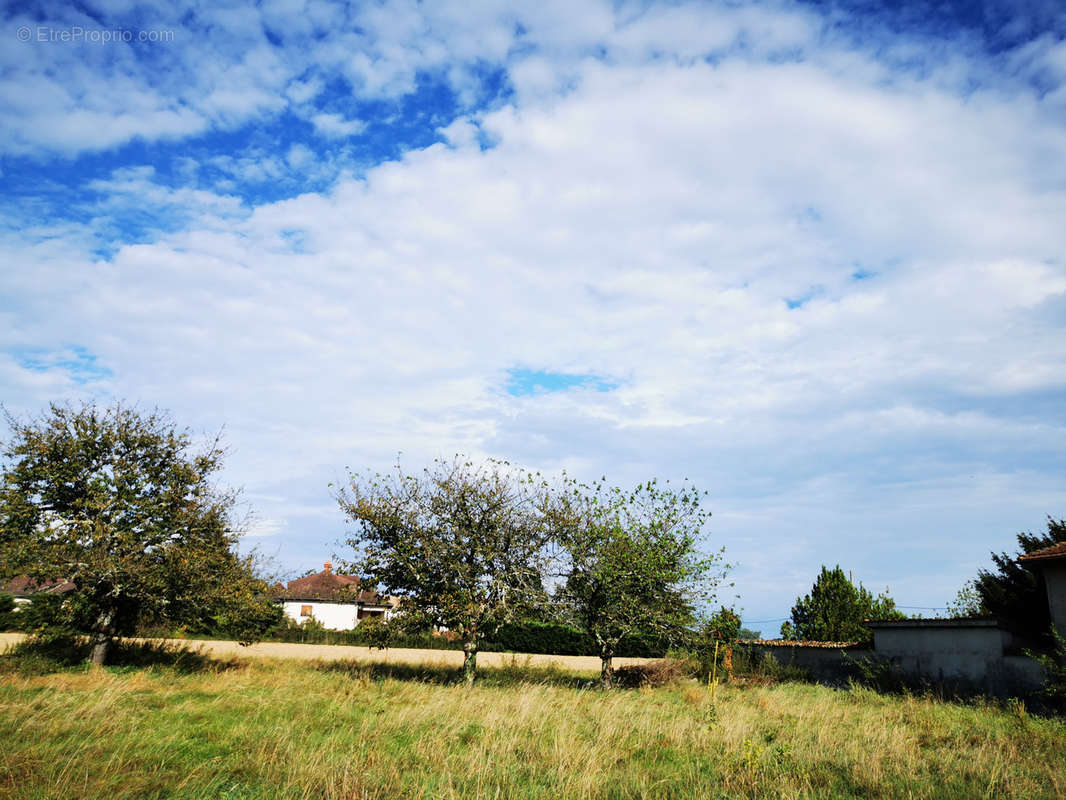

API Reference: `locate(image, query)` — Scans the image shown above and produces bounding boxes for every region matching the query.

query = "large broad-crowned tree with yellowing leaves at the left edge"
[0,404,274,663]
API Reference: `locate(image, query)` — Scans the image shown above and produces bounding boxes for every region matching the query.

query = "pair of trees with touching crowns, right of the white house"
[336,457,728,685]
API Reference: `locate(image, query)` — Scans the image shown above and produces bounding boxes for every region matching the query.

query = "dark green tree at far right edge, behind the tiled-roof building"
[974,516,1066,649]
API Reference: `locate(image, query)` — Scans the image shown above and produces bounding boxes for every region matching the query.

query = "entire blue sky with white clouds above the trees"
[0,0,1066,634]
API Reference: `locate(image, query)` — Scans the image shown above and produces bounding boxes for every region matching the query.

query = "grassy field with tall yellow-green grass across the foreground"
[0,659,1066,800]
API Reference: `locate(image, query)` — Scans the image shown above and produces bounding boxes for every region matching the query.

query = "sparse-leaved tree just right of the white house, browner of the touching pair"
[337,458,551,683]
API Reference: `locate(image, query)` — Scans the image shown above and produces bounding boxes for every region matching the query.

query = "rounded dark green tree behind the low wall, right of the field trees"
[781,565,904,642]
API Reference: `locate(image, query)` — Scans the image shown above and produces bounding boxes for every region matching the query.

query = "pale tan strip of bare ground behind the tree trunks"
[0,634,655,672]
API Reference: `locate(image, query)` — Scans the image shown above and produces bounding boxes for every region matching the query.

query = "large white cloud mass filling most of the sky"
[0,0,1066,619]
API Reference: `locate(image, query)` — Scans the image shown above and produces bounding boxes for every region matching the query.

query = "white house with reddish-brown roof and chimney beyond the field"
[278,561,399,630]
